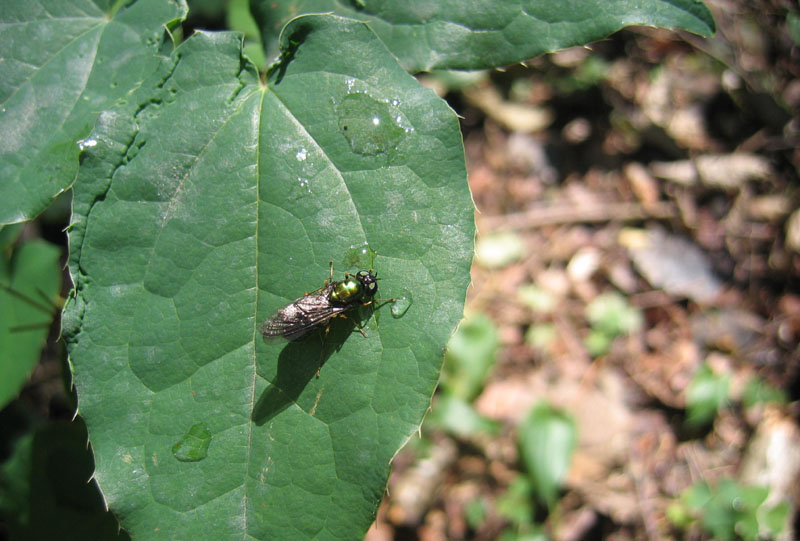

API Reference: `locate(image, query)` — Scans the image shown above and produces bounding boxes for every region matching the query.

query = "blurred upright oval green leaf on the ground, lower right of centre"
[518,403,577,507]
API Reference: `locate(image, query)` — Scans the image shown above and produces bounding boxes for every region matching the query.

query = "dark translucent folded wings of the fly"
[259,284,345,340]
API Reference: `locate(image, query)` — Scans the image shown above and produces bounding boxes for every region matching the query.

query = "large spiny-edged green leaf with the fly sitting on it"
[64,16,474,539]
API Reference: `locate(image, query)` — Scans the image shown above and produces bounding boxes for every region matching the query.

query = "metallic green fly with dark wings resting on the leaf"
[259,261,395,377]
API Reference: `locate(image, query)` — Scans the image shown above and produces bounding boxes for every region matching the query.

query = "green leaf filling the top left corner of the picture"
[0,0,186,223]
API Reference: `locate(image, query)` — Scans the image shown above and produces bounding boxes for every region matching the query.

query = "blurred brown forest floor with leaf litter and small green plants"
[368,0,800,541]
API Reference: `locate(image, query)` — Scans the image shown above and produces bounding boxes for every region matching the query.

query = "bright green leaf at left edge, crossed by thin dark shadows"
[0,240,61,409]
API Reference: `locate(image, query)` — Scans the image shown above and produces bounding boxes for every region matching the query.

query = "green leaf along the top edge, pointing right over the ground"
[250,0,714,72]
